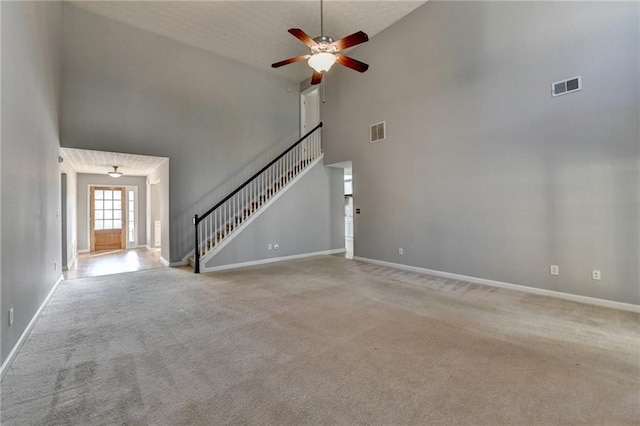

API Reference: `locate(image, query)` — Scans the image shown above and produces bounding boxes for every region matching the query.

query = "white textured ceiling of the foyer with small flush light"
[60,148,166,176]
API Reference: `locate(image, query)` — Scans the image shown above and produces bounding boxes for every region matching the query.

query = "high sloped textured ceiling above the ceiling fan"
[67,0,425,81]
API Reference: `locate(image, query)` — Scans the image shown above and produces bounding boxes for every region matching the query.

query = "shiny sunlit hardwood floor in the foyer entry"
[64,248,164,280]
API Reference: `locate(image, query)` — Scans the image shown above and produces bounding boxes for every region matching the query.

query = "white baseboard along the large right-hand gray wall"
[353,256,640,313]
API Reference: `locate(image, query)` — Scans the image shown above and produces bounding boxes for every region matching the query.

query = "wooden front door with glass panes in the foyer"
[90,186,127,251]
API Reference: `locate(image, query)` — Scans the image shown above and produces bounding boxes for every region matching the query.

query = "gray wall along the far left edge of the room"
[0,2,62,362]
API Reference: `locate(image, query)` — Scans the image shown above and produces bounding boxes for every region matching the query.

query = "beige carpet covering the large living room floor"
[1,256,640,426]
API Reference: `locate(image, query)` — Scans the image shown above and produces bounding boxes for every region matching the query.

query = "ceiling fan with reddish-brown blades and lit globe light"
[271,0,369,84]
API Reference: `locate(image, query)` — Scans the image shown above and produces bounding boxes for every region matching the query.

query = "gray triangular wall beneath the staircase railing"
[206,163,345,267]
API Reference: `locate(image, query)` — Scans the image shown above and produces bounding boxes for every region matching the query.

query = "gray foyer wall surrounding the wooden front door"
[77,173,147,251]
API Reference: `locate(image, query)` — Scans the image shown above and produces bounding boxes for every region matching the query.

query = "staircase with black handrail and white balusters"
[189,123,322,273]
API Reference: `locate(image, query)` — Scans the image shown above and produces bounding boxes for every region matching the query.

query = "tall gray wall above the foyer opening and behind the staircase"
[61,4,299,261]
